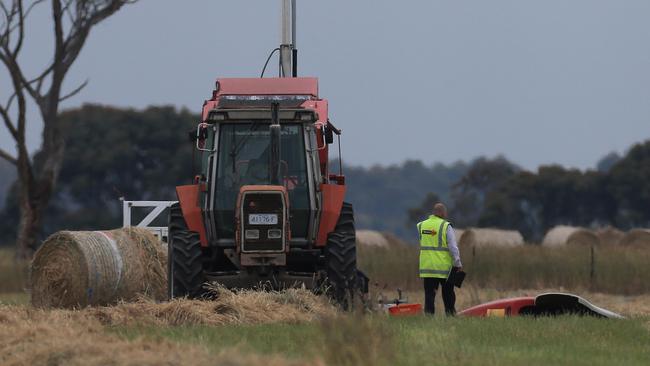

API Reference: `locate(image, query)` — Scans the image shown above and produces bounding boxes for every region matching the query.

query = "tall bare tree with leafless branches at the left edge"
[0,0,137,259]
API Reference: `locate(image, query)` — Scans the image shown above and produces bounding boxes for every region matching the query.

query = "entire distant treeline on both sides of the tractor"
[0,105,650,243]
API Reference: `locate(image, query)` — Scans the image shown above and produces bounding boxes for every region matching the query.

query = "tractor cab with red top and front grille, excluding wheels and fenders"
[197,78,326,251]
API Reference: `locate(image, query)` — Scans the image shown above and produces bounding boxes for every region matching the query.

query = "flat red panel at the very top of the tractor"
[217,78,318,98]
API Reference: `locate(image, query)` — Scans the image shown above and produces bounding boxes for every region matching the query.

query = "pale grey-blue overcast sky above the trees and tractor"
[0,0,650,169]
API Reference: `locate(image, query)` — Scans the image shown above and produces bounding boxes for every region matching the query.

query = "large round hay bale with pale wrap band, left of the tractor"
[31,228,167,308]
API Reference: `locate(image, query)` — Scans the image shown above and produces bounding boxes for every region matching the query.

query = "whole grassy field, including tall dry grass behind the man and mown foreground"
[0,240,650,365]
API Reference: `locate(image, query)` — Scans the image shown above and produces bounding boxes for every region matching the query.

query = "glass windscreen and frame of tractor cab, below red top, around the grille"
[204,103,321,246]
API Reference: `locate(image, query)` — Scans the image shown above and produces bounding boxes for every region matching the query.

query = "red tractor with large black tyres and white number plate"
[168,1,367,307]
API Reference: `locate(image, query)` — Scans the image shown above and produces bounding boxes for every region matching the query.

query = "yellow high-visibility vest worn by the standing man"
[418,215,453,278]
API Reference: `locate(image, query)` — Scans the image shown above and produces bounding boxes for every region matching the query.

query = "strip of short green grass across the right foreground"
[110,316,650,365]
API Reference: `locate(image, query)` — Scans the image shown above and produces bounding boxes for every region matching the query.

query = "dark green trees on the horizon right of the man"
[470,141,650,241]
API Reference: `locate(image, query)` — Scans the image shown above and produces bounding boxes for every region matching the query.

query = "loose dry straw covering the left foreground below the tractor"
[0,290,336,365]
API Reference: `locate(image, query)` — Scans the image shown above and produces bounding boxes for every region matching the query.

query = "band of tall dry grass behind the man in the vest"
[358,245,650,295]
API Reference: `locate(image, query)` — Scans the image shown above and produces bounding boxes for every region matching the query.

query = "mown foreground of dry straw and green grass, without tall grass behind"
[0,290,650,365]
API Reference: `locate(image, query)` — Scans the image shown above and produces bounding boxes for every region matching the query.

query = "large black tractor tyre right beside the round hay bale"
[167,203,205,299]
